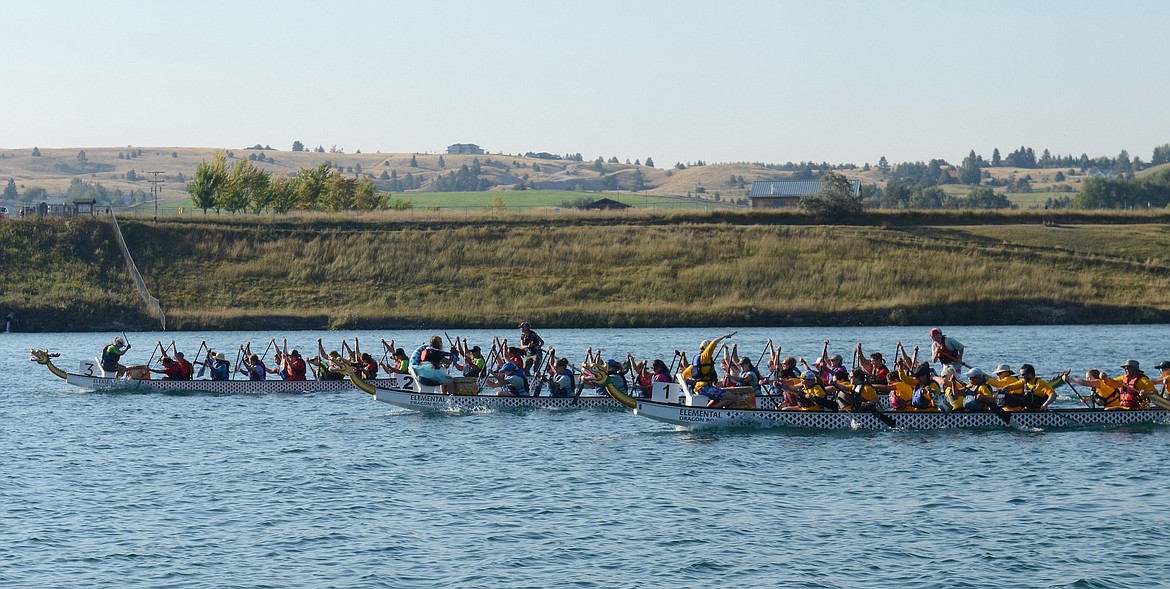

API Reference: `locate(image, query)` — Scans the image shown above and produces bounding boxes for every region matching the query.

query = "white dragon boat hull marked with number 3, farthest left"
[29,350,379,393]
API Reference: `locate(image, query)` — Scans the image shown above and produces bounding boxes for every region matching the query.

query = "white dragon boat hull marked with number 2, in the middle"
[342,367,621,412]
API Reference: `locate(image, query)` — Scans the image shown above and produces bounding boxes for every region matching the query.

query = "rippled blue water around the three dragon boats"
[0,326,1170,588]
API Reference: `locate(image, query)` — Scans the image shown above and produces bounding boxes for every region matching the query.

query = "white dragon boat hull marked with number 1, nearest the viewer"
[610,377,1170,430]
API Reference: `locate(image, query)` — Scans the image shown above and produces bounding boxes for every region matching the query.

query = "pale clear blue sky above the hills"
[0,0,1170,166]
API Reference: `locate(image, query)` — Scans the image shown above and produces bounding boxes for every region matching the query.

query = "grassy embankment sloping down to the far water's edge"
[0,210,1170,330]
